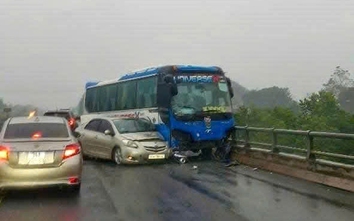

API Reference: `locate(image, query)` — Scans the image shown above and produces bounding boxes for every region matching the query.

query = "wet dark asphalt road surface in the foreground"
[0,160,354,221]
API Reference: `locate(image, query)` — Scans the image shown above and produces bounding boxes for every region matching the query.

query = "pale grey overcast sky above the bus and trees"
[0,0,354,108]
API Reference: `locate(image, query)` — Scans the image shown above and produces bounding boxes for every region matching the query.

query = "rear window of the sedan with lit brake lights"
[4,123,69,139]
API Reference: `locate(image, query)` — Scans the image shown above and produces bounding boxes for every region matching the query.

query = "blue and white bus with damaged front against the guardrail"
[78,65,235,153]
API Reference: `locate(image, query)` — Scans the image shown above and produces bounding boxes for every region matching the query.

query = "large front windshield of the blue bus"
[171,78,231,117]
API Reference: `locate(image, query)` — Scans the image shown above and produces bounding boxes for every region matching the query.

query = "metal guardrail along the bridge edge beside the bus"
[235,126,354,166]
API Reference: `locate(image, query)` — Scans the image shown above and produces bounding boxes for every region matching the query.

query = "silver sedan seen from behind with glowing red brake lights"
[0,116,83,193]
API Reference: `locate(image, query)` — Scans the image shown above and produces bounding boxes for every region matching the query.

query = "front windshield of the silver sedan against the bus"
[113,119,156,134]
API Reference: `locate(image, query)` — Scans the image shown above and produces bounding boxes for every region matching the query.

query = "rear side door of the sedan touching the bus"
[79,119,101,156]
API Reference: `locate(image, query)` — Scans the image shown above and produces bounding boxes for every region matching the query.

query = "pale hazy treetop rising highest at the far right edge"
[323,66,354,97]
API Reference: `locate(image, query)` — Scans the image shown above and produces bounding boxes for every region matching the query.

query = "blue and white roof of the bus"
[85,65,221,89]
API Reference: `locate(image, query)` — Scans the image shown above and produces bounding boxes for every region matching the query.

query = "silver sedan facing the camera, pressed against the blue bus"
[76,117,172,164]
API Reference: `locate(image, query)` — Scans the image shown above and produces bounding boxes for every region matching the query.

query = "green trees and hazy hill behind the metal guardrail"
[235,66,354,162]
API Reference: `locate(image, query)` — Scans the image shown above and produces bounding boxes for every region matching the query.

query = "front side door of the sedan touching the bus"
[97,119,115,159]
